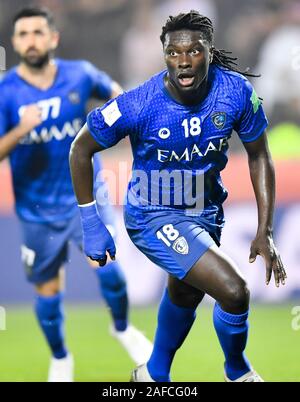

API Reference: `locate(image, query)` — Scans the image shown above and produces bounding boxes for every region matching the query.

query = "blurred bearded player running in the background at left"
[0,8,152,382]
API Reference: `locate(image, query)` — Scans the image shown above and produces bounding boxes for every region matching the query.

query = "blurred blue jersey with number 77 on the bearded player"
[0,59,112,223]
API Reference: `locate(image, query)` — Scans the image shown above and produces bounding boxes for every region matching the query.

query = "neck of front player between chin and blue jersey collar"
[165,76,209,106]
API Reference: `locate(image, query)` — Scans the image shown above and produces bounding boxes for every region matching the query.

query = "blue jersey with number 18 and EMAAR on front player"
[87,65,268,233]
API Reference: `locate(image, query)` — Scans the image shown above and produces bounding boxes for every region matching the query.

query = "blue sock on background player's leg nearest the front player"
[96,262,128,331]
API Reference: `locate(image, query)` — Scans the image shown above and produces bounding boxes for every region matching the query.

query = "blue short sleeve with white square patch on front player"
[87,91,141,148]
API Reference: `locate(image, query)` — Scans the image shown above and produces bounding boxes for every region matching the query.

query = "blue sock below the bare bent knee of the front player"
[214,303,251,381]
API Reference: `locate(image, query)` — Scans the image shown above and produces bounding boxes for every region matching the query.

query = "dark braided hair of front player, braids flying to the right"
[160,10,258,77]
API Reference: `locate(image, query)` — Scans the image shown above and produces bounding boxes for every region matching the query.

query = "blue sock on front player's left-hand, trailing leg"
[147,290,196,382]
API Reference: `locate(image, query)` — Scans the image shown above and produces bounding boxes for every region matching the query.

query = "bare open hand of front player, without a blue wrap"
[249,235,287,288]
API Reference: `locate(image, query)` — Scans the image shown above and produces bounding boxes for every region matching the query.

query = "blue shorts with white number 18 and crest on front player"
[125,207,220,280]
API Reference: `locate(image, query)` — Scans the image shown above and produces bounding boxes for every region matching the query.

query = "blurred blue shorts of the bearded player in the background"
[20,205,116,284]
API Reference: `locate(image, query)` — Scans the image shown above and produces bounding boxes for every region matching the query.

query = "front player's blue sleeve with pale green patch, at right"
[234,79,268,142]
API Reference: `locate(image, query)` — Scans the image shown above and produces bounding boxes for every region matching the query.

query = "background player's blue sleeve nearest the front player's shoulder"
[84,61,113,100]
